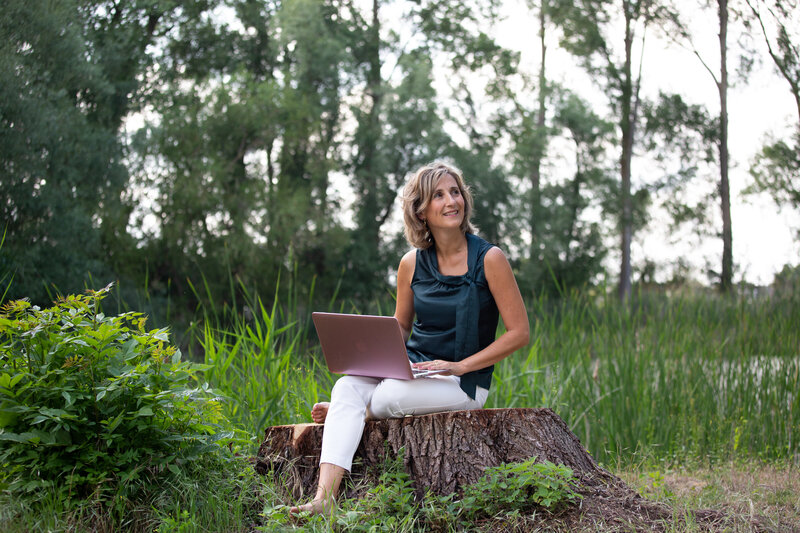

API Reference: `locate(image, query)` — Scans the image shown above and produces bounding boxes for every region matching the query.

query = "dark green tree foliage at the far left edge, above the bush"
[0,0,123,302]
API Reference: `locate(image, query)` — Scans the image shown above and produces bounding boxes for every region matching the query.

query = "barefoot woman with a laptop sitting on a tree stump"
[290,162,529,513]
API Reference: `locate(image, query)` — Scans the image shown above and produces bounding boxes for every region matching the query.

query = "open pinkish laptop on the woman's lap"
[311,312,444,379]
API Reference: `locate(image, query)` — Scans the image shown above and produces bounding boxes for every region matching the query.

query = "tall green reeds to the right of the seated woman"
[490,284,800,461]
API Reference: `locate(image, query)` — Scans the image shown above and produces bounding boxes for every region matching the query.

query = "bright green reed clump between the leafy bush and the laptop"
[193,272,343,437]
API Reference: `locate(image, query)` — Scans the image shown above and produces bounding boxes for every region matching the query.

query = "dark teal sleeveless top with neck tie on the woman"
[406,233,498,399]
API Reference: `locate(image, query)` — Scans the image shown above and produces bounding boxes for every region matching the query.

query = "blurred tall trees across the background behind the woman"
[0,0,800,313]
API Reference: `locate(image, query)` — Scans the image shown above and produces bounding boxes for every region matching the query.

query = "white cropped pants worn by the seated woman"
[319,376,489,471]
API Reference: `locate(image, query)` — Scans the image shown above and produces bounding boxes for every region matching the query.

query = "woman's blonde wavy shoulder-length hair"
[403,161,477,249]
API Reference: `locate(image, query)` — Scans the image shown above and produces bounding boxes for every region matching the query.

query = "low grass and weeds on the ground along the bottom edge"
[6,450,800,533]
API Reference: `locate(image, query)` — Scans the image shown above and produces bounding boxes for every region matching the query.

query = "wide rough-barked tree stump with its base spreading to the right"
[255,408,767,531]
